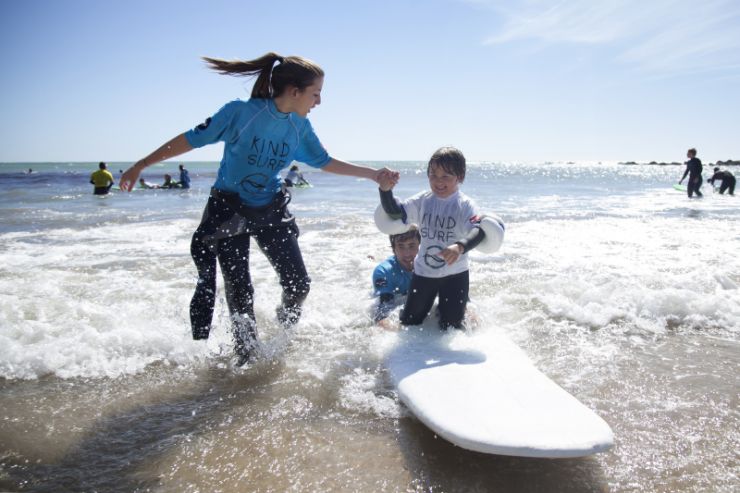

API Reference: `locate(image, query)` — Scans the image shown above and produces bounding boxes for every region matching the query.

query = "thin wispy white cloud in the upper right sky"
[476,0,740,75]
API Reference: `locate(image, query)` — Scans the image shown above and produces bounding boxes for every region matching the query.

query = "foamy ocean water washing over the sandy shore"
[0,162,740,492]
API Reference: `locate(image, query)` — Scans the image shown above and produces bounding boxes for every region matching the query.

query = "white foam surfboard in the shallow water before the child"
[386,327,614,458]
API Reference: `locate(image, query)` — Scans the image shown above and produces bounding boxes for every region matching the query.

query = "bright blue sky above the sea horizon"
[0,0,740,162]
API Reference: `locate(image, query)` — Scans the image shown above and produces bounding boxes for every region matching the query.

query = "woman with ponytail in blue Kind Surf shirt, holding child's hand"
[121,53,398,365]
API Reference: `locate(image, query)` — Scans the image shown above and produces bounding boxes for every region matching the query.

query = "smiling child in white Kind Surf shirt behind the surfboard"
[380,147,485,329]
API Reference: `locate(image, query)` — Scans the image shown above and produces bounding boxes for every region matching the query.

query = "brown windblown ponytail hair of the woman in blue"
[203,52,324,99]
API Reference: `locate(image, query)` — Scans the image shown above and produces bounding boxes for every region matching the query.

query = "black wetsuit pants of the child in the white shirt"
[401,271,470,330]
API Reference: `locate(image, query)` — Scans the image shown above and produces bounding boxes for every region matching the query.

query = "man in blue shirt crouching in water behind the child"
[373,226,421,329]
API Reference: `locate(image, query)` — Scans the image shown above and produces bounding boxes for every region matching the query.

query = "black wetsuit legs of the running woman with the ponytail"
[190,190,311,339]
